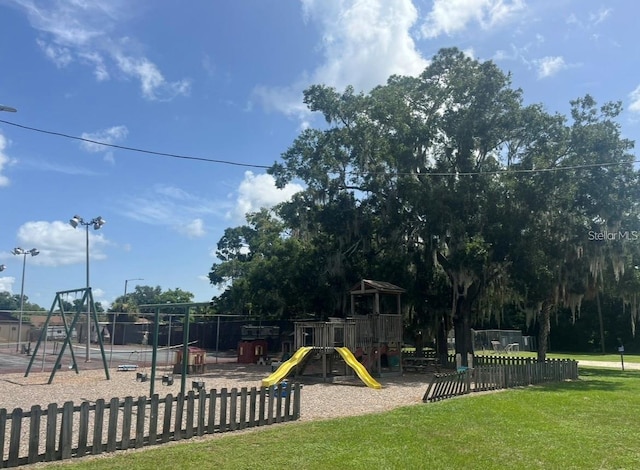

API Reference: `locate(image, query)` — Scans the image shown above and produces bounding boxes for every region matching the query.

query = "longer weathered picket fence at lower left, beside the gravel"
[0,382,301,468]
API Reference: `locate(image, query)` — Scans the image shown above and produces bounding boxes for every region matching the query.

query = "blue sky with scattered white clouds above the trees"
[0,0,640,309]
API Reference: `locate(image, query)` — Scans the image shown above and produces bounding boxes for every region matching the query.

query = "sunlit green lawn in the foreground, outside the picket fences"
[41,368,640,470]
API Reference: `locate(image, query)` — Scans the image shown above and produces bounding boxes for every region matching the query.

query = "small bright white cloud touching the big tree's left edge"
[227,171,303,222]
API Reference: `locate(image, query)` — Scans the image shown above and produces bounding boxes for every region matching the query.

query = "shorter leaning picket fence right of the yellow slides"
[422,359,578,402]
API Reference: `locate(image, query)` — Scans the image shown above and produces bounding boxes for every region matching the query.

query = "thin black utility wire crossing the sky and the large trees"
[0,119,640,176]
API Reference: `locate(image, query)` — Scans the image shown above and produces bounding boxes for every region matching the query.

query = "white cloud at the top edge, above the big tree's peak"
[421,0,525,38]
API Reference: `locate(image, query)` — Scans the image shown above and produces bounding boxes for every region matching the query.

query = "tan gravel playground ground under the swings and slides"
[0,364,430,420]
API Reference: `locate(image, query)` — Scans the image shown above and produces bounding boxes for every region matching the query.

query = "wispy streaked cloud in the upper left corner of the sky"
[13,0,191,101]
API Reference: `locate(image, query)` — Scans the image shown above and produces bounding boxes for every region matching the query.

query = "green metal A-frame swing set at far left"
[24,287,110,384]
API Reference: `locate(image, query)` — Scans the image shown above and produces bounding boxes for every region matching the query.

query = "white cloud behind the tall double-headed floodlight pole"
[17,221,109,266]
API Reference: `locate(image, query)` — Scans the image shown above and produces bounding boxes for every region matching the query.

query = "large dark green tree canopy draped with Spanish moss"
[209,48,640,356]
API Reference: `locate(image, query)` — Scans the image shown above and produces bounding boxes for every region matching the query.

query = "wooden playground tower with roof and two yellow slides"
[263,279,405,388]
